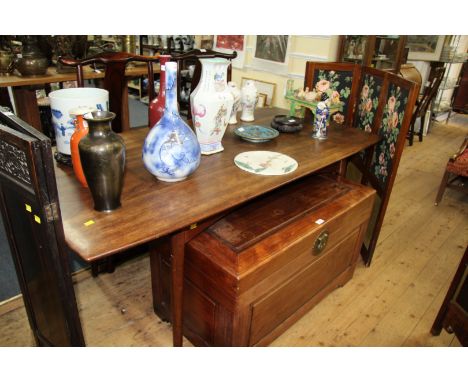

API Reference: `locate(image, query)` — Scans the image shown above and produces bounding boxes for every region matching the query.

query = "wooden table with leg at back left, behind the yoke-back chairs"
[0,65,159,131]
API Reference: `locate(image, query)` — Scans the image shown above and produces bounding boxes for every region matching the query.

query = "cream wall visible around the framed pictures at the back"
[229,35,338,108]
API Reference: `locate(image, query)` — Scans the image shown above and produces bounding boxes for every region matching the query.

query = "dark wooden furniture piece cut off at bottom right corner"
[431,247,468,346]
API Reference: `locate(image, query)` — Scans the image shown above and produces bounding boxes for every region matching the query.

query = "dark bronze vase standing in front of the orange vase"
[78,111,125,212]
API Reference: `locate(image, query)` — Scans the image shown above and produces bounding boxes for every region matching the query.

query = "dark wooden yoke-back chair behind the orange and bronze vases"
[58,52,159,133]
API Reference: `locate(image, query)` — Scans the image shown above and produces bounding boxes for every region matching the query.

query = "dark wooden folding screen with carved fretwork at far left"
[0,107,85,346]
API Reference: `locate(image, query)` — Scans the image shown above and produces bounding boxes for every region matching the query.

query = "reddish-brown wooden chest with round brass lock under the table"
[153,176,375,346]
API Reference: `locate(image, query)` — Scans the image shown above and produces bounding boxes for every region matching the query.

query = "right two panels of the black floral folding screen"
[349,68,419,265]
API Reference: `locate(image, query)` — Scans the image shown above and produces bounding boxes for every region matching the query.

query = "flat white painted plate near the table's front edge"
[234,151,298,175]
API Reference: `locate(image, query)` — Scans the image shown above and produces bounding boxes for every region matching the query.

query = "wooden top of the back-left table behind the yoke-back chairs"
[0,64,159,87]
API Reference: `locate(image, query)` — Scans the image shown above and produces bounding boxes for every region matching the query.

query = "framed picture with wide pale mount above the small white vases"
[252,35,290,74]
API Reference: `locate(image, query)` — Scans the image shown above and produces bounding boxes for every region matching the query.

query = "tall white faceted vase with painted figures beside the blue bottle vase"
[190,58,234,155]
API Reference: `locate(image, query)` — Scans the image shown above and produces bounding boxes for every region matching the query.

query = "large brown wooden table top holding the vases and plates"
[55,108,379,261]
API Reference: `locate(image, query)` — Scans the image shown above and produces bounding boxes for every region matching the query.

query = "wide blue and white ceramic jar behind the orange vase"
[49,88,109,165]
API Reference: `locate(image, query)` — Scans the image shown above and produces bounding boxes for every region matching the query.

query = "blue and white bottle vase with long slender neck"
[143,62,201,182]
